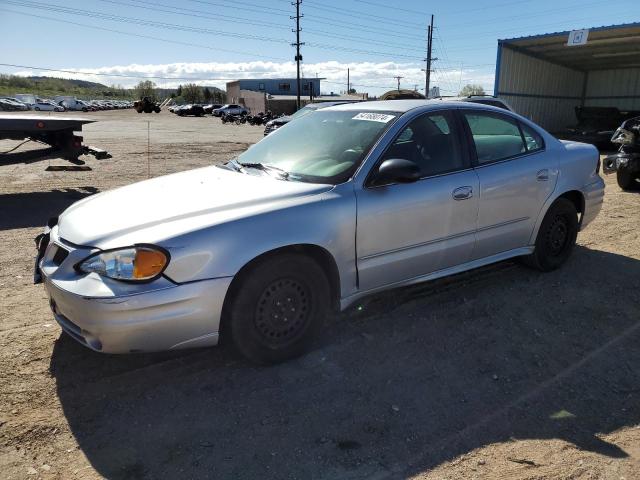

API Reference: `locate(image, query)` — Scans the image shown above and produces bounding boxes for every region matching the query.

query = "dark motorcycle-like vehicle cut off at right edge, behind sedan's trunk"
[603,117,640,190]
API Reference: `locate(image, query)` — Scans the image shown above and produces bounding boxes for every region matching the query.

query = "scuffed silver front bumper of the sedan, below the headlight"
[40,227,231,353]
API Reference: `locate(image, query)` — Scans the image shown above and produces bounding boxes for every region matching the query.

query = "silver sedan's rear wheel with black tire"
[523,198,578,272]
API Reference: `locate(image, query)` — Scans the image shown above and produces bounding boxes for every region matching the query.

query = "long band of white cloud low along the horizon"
[16,61,493,95]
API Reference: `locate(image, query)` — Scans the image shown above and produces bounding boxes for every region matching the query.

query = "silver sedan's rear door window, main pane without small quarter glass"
[464,112,527,165]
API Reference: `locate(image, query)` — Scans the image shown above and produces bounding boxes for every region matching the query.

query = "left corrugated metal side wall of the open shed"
[496,45,584,132]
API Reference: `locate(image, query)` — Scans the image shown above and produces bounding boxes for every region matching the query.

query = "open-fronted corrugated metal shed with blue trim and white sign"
[494,23,640,132]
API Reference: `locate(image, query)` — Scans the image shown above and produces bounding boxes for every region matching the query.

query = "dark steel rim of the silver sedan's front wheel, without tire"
[255,278,311,345]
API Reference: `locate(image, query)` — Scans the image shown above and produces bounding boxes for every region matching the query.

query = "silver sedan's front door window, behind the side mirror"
[382,112,464,178]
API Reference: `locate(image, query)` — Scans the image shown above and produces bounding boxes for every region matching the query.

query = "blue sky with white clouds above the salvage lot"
[0,0,640,95]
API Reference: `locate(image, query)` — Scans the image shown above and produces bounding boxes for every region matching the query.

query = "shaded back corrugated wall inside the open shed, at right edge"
[585,68,640,110]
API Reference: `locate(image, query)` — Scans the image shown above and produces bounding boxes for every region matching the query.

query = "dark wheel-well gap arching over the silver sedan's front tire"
[220,244,340,336]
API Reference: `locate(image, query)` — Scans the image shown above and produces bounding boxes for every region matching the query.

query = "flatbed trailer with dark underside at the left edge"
[0,115,109,165]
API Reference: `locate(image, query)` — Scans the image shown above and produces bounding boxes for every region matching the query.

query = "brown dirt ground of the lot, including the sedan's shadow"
[0,110,640,480]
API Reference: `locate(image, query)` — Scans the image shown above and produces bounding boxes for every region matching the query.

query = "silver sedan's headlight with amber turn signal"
[76,245,169,281]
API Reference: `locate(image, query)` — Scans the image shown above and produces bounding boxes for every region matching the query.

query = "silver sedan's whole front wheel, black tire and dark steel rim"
[228,254,330,364]
